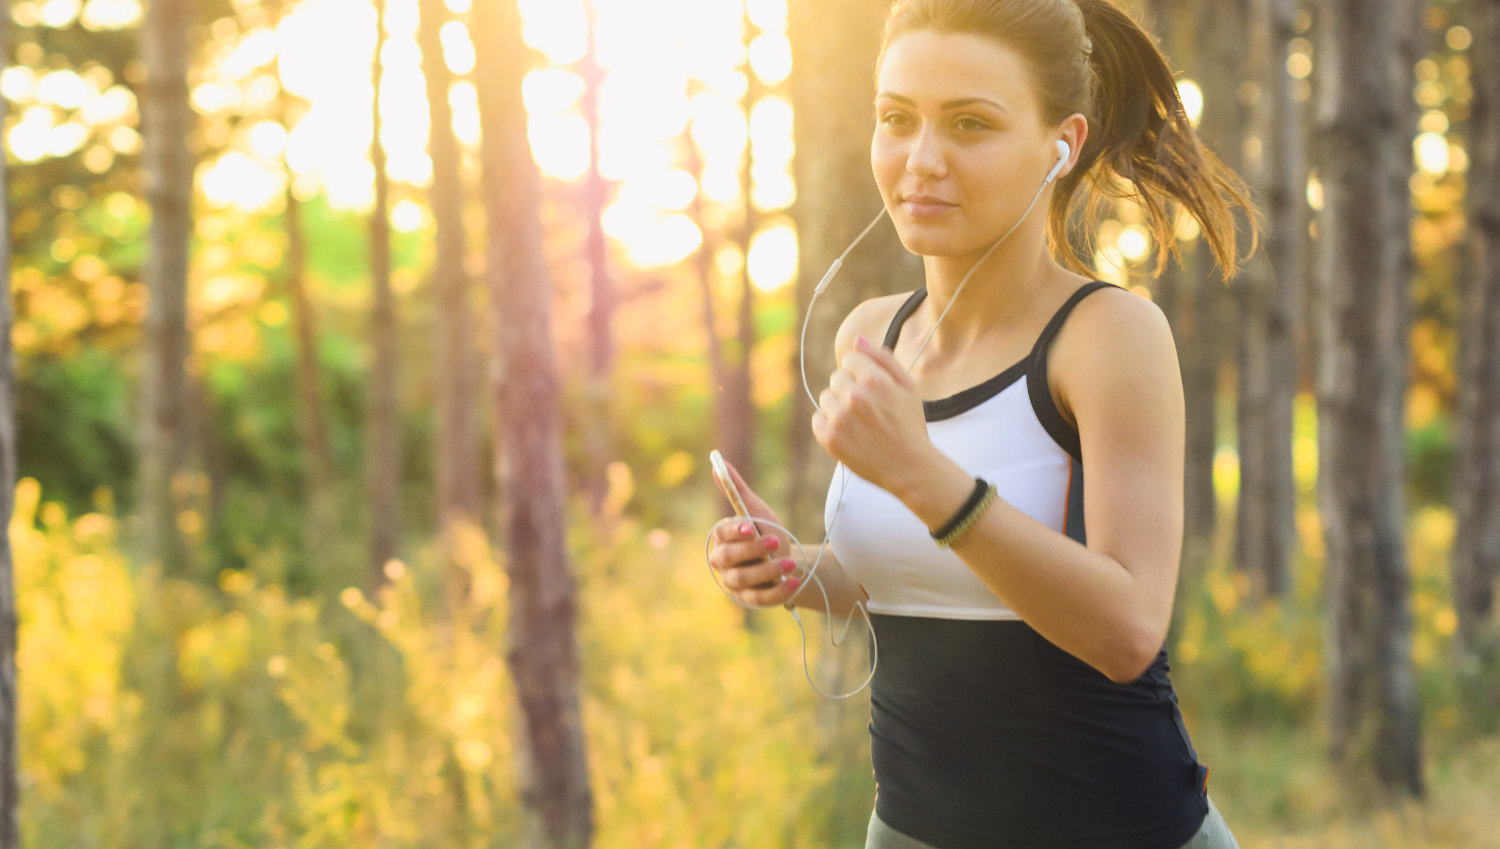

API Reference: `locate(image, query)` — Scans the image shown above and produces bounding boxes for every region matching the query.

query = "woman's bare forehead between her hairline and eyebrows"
[876,32,1035,111]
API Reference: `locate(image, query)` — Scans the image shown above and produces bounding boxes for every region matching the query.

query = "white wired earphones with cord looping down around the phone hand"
[704,138,1073,699]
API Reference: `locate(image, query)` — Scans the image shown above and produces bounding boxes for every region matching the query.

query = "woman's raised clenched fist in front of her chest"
[813,338,935,495]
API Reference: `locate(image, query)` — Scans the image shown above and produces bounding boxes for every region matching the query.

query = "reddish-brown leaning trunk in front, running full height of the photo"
[471,0,594,849]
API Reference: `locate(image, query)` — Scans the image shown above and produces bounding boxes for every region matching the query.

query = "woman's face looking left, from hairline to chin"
[870,32,1059,257]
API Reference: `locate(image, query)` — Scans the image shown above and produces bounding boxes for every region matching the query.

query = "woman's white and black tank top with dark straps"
[824,281,1208,849]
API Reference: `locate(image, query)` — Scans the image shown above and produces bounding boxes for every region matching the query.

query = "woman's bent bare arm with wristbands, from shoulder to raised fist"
[815,296,1185,683]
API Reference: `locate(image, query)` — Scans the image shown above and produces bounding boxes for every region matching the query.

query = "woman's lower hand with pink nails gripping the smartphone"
[708,462,801,608]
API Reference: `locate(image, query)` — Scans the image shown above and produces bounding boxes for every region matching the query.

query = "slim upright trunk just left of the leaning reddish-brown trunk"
[417,0,480,545]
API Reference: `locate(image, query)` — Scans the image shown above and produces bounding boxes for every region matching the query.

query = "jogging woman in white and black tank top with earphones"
[710,0,1248,849]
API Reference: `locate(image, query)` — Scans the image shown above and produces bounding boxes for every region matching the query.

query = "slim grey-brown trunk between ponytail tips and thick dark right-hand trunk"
[1235,0,1307,597]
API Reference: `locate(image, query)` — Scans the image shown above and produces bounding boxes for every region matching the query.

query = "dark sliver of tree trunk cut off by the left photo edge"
[0,8,21,849]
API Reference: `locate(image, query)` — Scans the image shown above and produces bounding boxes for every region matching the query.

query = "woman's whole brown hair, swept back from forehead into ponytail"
[881,0,1260,279]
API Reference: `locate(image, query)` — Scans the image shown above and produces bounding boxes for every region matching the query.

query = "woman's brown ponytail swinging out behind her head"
[1049,0,1260,279]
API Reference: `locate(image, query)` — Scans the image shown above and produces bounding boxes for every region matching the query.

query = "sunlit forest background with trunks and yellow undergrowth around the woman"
[0,0,1500,849]
